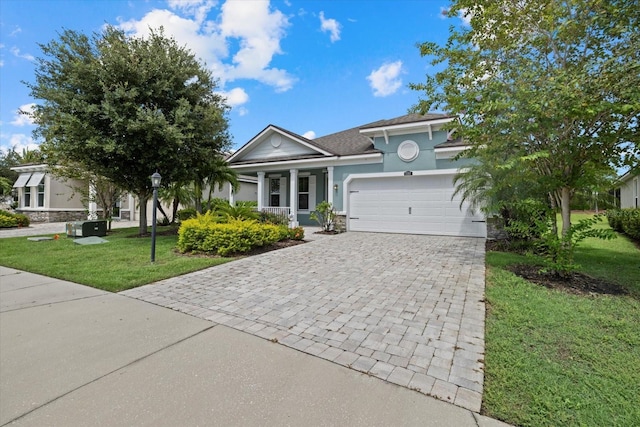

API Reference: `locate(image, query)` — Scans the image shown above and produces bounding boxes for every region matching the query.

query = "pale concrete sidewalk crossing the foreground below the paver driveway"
[0,267,504,426]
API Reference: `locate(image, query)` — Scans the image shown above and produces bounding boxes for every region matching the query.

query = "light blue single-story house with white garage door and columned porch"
[228,114,487,237]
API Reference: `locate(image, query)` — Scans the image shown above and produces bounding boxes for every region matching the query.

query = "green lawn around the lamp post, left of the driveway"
[0,227,233,292]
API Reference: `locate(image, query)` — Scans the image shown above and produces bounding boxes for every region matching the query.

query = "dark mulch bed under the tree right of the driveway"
[486,240,628,296]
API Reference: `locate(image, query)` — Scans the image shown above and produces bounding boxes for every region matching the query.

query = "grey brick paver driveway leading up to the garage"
[122,232,485,412]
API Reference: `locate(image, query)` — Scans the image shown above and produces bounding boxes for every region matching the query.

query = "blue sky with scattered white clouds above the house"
[0,0,465,154]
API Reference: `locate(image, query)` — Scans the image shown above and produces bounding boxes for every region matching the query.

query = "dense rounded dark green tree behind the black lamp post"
[25,27,230,234]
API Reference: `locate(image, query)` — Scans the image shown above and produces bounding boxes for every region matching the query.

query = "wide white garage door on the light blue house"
[347,175,487,237]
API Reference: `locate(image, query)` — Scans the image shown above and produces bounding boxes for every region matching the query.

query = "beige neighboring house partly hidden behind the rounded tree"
[11,164,257,222]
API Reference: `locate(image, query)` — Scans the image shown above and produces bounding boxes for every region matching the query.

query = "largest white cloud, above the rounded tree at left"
[120,0,296,92]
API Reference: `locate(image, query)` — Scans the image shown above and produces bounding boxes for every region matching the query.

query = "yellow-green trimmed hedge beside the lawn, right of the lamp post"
[177,214,290,256]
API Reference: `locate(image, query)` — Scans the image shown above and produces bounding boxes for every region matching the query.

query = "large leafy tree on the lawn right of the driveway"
[411,0,640,241]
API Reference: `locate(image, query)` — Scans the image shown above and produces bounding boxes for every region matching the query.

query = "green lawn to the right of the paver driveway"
[483,216,640,426]
